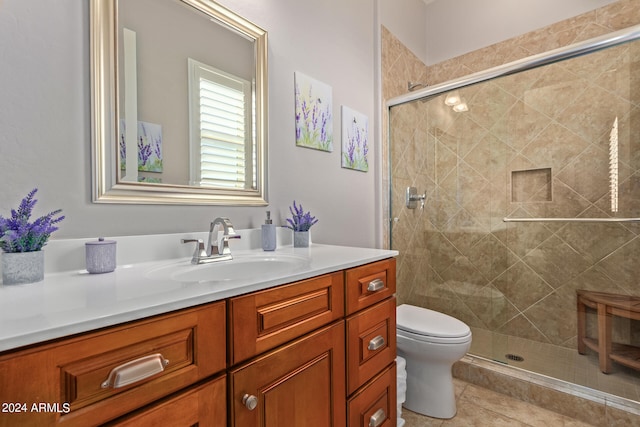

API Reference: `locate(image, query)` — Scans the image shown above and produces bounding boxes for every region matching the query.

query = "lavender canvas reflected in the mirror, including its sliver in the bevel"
[120,121,162,172]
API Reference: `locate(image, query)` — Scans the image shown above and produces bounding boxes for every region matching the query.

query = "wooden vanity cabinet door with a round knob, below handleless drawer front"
[229,321,346,427]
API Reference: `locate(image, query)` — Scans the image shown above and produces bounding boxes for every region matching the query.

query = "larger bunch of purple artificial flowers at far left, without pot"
[0,188,64,252]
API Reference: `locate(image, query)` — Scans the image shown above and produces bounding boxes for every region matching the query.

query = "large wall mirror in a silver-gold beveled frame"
[90,0,268,206]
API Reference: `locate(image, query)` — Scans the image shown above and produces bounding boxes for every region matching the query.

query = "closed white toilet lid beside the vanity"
[396,304,471,338]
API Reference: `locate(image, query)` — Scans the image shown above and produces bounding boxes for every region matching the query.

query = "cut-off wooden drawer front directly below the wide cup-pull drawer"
[107,376,227,427]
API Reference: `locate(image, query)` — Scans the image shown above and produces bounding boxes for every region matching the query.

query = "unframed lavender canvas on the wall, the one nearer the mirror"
[295,72,333,151]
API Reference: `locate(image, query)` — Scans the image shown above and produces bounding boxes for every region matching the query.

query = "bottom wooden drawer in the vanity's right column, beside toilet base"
[347,363,398,427]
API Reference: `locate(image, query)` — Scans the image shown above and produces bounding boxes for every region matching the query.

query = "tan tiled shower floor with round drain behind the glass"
[469,328,640,402]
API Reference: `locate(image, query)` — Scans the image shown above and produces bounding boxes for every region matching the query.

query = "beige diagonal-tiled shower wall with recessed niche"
[382,0,640,360]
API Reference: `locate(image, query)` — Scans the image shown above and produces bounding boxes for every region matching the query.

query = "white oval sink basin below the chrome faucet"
[146,254,309,283]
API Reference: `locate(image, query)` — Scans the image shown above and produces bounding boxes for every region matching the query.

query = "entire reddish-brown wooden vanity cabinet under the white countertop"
[0,259,396,427]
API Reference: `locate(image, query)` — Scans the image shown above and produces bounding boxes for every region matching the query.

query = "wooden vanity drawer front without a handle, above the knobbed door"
[229,272,344,365]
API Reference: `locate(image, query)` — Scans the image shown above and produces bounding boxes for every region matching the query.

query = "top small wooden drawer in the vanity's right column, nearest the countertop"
[345,258,396,315]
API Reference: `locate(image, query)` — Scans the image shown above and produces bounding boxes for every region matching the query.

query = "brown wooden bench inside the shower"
[577,290,640,374]
